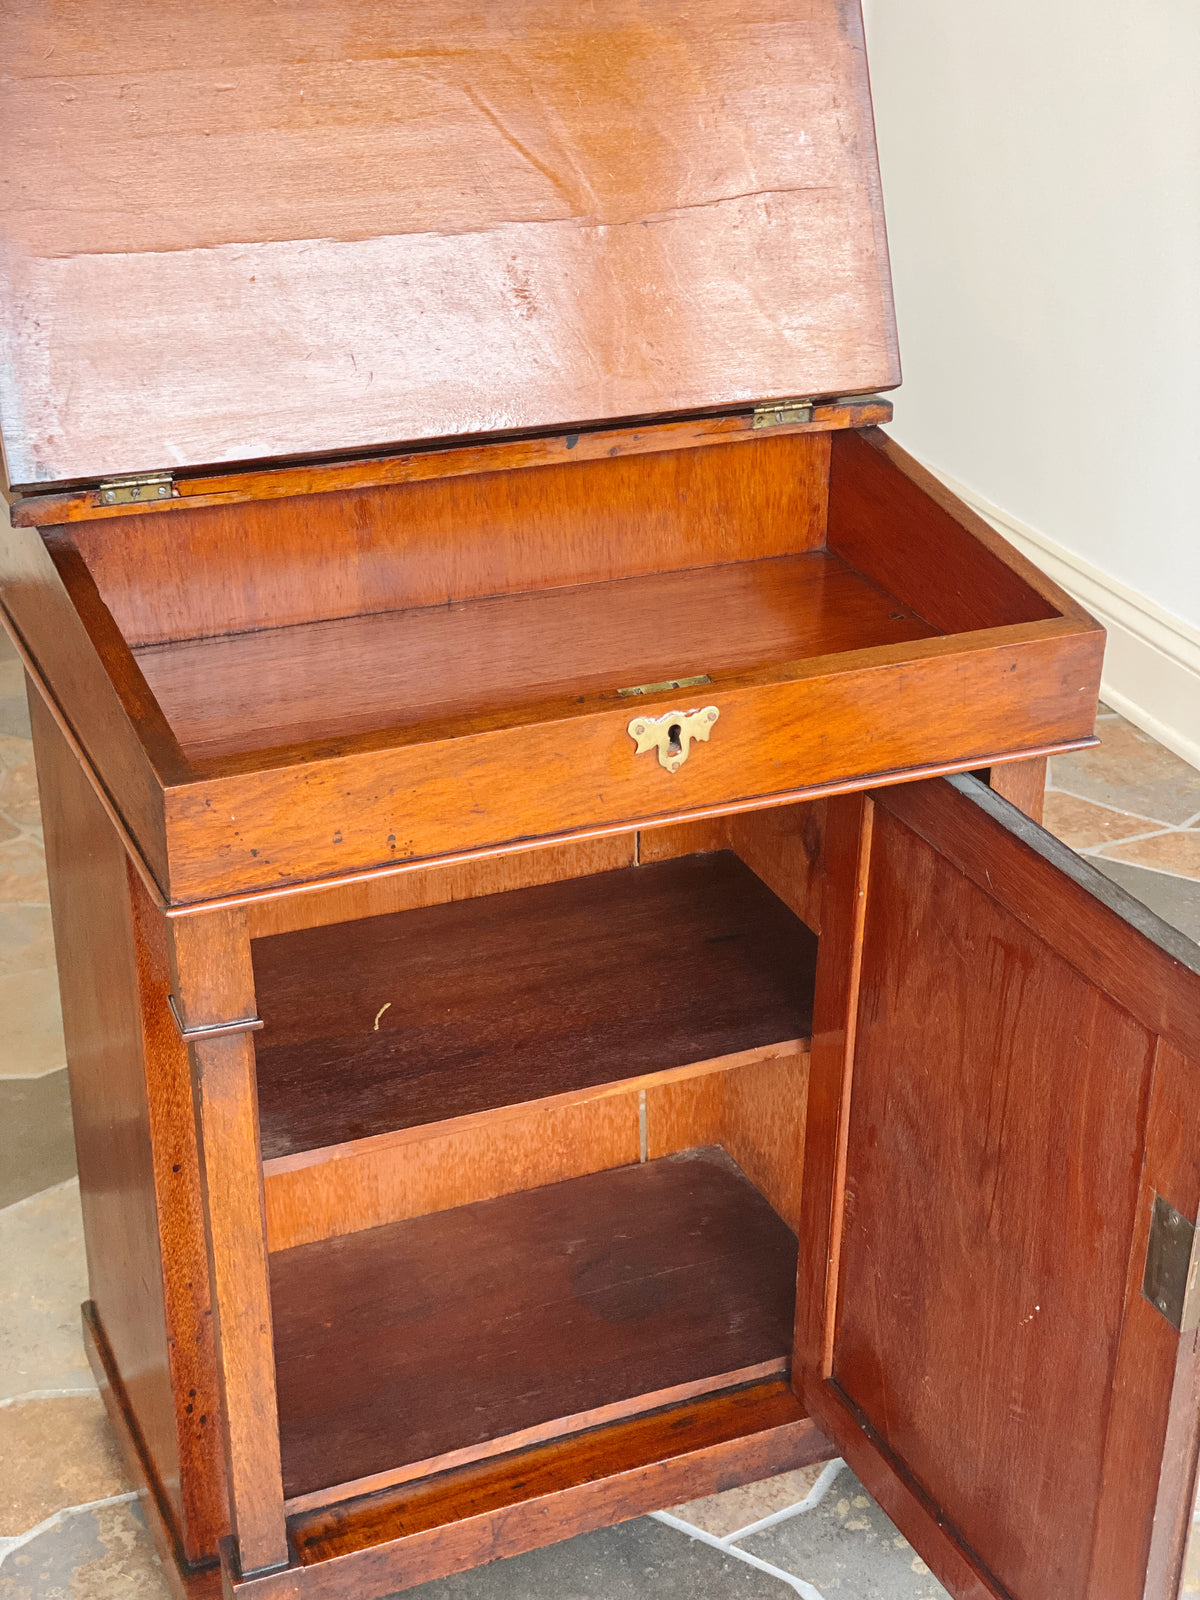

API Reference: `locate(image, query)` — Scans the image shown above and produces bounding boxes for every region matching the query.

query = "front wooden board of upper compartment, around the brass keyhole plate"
[166,622,1101,902]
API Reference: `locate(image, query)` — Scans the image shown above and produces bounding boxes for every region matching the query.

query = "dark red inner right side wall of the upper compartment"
[826,427,1102,633]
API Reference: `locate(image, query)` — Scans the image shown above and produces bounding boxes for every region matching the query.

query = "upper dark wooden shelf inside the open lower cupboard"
[253,851,816,1160]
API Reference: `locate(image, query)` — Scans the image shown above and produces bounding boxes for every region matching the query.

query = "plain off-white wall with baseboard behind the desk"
[864,0,1200,762]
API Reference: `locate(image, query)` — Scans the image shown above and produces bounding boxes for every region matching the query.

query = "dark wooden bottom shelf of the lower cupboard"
[270,1149,797,1509]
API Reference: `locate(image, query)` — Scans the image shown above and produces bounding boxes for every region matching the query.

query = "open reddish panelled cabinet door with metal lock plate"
[794,778,1200,1600]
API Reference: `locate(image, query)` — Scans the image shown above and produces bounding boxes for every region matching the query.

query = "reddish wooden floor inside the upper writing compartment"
[134,550,938,760]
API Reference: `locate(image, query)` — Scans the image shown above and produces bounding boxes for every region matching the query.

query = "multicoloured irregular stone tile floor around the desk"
[0,617,1200,1600]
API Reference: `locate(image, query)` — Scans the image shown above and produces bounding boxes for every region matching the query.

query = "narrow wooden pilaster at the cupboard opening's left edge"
[171,912,288,1573]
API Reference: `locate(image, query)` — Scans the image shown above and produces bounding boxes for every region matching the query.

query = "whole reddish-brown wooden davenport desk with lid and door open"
[0,0,1200,1600]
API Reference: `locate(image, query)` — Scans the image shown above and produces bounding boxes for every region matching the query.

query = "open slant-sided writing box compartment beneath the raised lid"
[3,405,1102,899]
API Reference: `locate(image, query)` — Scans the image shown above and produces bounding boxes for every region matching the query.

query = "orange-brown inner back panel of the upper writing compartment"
[72,434,829,645]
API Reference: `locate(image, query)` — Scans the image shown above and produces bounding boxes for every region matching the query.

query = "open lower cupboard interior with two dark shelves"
[253,806,819,1514]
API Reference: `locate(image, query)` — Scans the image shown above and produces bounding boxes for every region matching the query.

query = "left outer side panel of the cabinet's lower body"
[30,698,227,1562]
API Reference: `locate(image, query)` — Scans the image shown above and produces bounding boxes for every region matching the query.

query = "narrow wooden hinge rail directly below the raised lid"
[13,395,893,528]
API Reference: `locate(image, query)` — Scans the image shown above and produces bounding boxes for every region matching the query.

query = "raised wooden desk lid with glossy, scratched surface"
[0,0,899,486]
